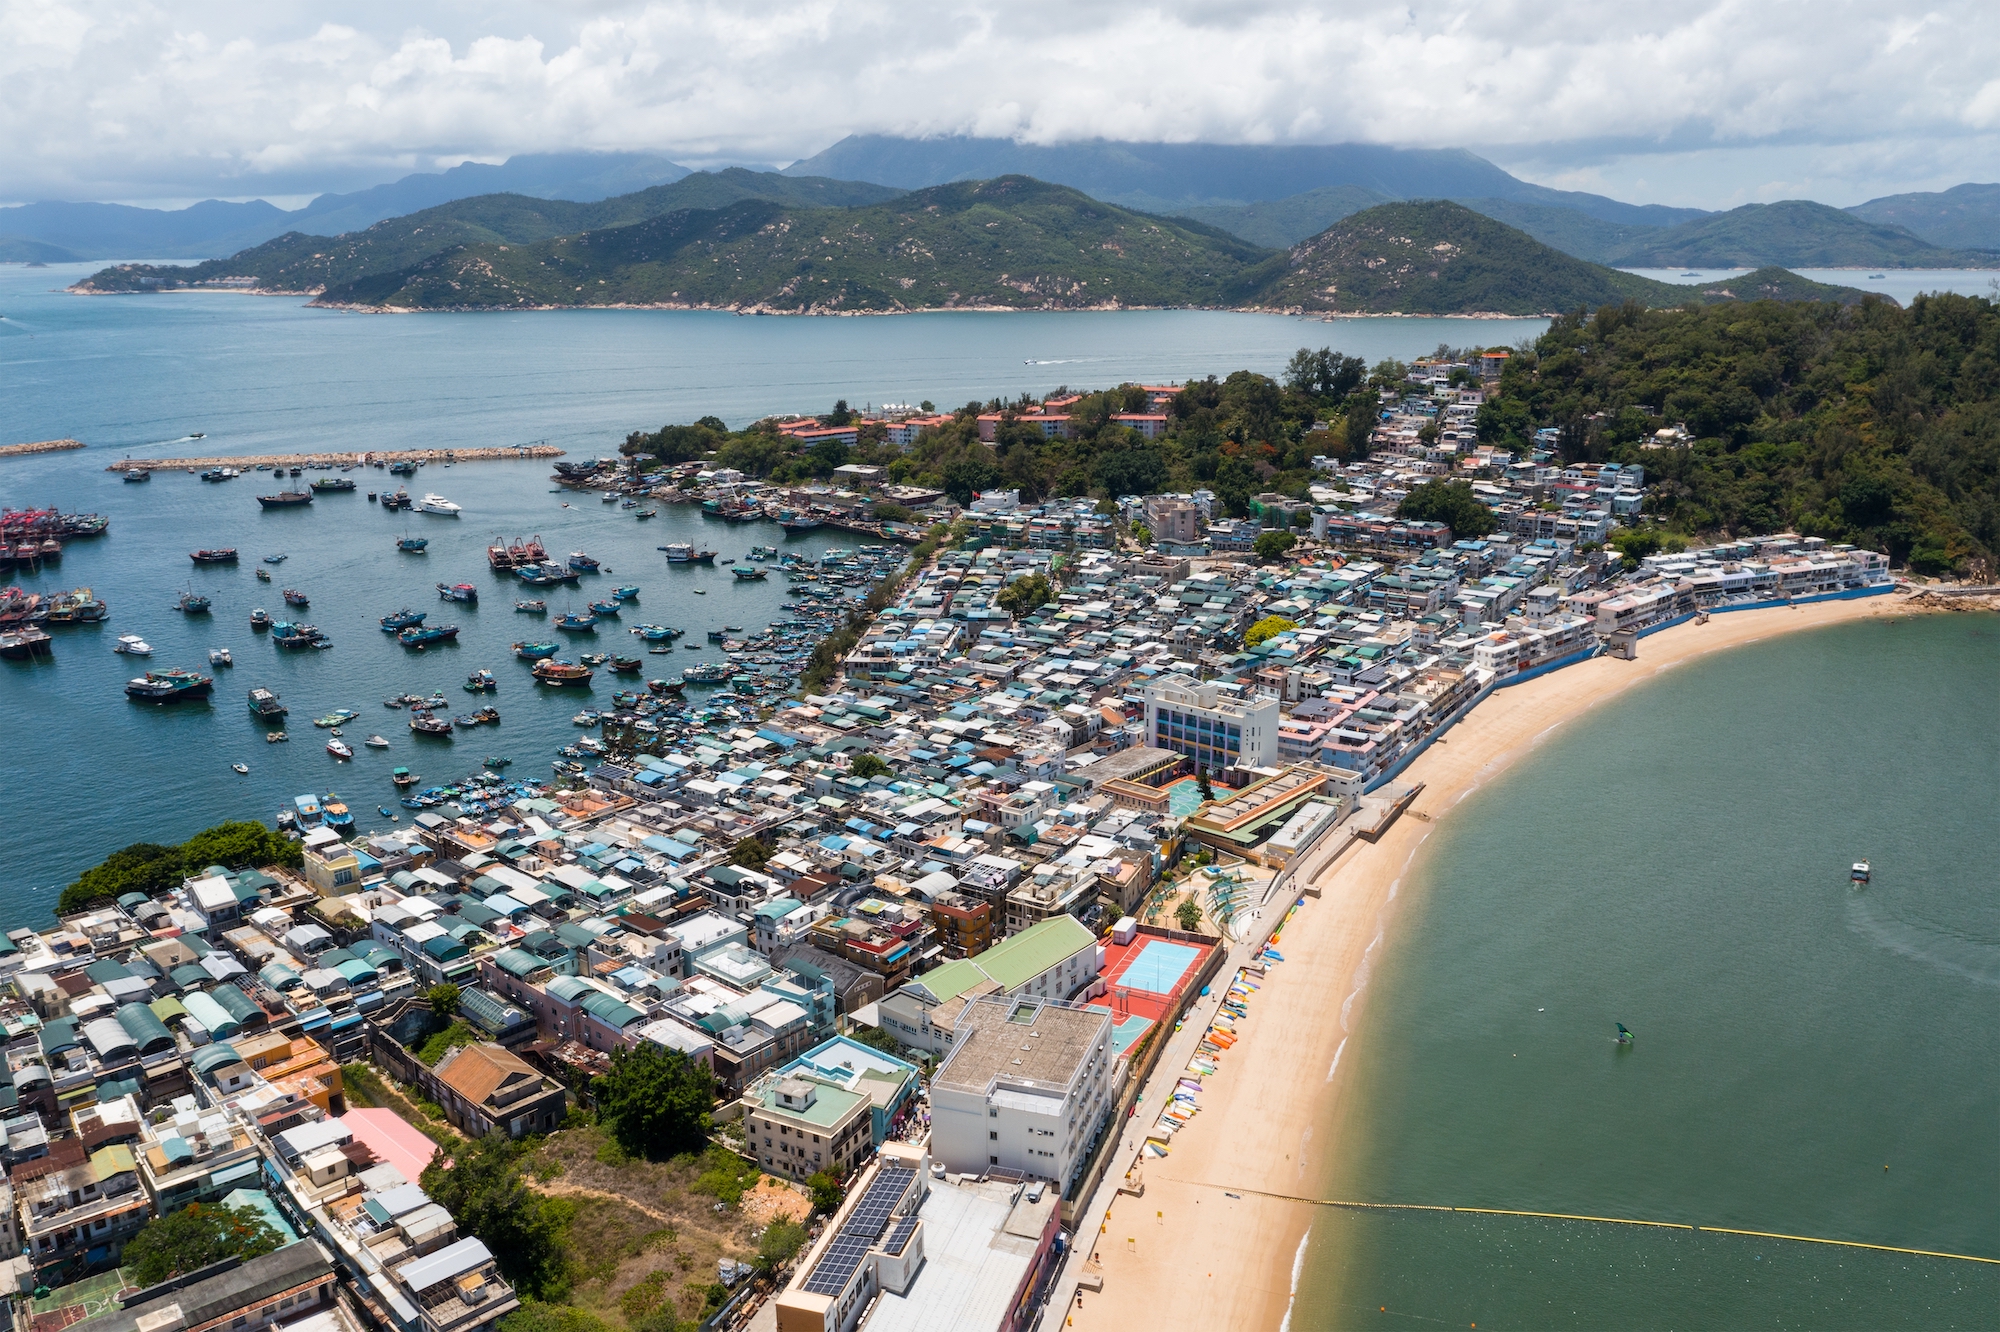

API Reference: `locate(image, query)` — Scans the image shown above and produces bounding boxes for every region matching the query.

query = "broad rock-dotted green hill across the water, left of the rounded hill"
[318,176,1282,314]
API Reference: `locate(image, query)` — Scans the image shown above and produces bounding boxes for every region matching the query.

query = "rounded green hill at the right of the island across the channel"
[1256,200,1690,314]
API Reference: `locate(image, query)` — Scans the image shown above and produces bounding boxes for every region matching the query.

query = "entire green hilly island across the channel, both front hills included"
[72,182,1864,316]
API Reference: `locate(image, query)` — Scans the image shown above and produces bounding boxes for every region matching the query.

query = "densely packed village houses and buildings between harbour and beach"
[0,354,1890,1332]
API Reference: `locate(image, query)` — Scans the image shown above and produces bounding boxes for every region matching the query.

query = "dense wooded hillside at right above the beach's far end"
[1480,296,2000,578]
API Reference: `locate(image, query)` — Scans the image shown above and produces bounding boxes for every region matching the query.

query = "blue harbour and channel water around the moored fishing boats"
[0,266,1544,928]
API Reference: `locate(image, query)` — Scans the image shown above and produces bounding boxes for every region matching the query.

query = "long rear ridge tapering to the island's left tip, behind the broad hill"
[74,166,900,294]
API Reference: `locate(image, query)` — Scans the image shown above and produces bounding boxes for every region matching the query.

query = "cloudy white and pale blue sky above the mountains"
[11,0,2000,208]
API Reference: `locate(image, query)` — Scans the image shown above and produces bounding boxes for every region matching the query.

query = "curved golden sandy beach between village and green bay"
[1072,594,1916,1332]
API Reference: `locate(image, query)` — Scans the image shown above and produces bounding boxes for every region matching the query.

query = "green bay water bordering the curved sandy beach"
[1292,614,2000,1328]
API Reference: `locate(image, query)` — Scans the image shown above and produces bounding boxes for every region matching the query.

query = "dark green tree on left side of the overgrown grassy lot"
[418,1132,576,1300]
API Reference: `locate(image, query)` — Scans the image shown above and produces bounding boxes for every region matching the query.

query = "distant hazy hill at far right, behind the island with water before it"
[1612,200,1992,268]
